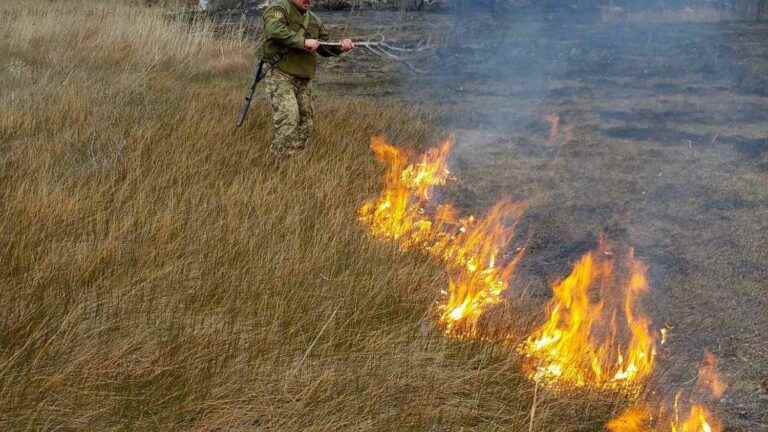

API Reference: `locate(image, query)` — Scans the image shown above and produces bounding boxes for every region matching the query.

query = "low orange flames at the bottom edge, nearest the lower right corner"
[606,353,726,432]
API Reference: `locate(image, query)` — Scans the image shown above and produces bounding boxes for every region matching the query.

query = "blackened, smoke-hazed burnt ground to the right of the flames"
[254,8,768,432]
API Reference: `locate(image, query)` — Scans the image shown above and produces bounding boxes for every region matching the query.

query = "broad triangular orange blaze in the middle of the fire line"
[520,245,656,390]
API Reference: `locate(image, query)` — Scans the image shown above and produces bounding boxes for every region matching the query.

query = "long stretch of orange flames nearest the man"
[359,138,523,336]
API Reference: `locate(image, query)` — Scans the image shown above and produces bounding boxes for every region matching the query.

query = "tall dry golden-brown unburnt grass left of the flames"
[0,0,614,431]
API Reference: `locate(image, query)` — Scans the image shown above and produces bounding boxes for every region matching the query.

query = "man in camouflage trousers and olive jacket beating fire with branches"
[261,0,354,157]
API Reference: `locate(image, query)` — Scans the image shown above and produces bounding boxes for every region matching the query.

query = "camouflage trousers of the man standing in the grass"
[265,69,314,156]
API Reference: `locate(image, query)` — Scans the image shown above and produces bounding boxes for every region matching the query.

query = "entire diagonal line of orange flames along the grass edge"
[358,126,726,432]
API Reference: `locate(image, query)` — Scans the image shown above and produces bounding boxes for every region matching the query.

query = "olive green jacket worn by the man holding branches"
[261,0,341,79]
